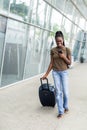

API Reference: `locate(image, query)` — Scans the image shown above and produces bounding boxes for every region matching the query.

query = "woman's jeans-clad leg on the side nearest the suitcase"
[52,70,64,114]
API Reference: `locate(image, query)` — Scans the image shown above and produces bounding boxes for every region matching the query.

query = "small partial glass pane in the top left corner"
[0,0,10,14]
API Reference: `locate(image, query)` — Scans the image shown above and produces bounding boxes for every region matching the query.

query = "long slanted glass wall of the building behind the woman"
[0,0,87,87]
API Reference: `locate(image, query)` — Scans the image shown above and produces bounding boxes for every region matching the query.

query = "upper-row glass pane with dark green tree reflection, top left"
[9,0,30,21]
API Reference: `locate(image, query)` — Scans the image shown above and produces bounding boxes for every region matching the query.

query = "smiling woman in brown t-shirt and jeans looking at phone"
[42,31,71,118]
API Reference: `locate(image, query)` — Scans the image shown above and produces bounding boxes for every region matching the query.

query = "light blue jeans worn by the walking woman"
[52,70,68,114]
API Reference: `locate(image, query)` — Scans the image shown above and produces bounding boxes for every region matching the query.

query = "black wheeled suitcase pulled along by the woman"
[39,78,56,107]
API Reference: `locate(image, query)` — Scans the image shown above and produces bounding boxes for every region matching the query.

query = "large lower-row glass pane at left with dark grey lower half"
[2,19,27,86]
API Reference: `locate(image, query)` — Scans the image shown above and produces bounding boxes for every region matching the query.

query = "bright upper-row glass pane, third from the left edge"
[31,0,52,29]
